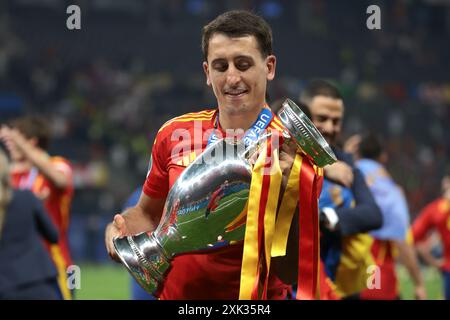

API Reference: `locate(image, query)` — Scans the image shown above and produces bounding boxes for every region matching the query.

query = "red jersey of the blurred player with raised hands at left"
[12,157,73,267]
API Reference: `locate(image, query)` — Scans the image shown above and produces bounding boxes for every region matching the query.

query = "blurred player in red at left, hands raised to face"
[0,116,73,299]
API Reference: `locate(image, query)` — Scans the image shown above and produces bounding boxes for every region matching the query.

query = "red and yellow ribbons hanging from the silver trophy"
[239,140,323,300]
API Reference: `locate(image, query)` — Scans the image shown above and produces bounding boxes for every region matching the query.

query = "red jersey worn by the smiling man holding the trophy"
[143,110,289,300]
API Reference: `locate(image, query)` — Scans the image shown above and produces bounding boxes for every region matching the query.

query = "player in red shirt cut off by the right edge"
[413,169,450,300]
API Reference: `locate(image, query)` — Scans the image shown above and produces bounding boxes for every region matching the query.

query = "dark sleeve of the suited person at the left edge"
[30,191,58,243]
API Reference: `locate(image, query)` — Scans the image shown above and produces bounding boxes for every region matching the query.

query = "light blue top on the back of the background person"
[356,159,409,240]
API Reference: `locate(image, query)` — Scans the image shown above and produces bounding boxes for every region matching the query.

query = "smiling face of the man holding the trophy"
[203,33,276,115]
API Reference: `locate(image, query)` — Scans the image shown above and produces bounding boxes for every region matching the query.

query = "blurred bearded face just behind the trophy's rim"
[309,96,344,145]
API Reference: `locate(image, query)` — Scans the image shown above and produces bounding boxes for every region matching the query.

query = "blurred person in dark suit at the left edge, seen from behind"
[0,149,62,300]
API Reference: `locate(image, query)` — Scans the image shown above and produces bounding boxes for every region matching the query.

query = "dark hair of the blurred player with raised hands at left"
[10,115,51,150]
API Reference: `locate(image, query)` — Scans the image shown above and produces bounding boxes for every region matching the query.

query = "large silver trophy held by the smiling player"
[114,99,336,294]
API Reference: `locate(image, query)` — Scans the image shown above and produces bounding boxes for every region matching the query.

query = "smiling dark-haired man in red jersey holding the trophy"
[105,11,324,299]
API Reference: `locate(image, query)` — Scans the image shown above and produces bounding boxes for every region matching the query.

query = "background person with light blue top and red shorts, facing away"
[344,134,426,300]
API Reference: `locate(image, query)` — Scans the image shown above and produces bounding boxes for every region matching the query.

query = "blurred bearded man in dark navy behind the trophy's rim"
[300,80,382,299]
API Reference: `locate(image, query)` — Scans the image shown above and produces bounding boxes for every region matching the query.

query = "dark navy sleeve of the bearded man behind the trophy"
[335,151,383,236]
